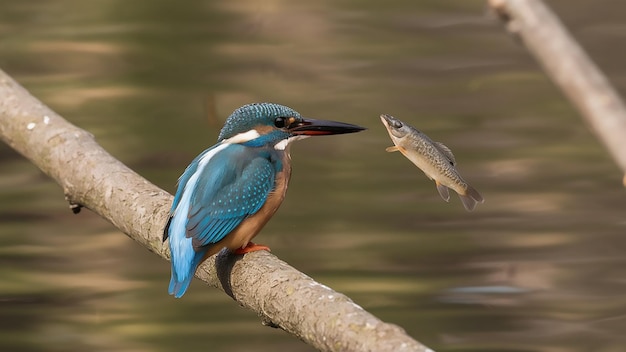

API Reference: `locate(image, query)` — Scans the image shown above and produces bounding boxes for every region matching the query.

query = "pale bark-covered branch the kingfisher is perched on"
[0,70,432,352]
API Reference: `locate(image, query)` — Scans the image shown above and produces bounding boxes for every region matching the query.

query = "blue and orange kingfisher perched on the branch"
[163,103,365,298]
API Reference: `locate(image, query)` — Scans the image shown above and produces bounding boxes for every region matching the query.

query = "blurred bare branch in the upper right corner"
[489,0,626,186]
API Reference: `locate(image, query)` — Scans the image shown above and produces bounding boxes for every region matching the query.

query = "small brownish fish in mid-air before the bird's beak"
[380,114,485,211]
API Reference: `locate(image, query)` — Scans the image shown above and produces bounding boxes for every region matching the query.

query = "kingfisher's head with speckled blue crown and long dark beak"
[217,103,365,150]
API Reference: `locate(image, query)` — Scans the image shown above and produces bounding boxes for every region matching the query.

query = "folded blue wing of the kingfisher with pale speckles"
[187,147,276,247]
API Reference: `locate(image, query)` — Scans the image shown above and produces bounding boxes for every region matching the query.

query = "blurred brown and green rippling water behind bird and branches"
[0,0,626,352]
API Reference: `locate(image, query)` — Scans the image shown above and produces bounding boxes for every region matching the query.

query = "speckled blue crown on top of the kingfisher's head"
[217,103,301,142]
